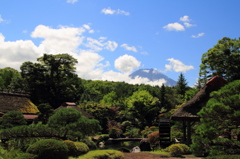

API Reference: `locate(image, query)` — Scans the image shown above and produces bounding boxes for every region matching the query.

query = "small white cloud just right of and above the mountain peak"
[165,58,194,72]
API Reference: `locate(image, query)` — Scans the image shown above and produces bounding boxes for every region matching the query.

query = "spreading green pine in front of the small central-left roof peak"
[47,108,100,140]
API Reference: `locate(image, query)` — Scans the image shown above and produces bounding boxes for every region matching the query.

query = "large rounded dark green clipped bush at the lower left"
[27,139,68,159]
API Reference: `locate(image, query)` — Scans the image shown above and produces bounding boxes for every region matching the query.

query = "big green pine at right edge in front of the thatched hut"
[192,80,240,155]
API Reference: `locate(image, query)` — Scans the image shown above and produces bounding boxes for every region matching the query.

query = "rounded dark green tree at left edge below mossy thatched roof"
[0,111,27,129]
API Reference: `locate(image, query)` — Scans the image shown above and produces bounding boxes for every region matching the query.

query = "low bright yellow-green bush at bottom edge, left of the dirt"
[74,150,124,159]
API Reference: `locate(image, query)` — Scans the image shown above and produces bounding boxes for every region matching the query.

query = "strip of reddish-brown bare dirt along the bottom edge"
[124,152,201,159]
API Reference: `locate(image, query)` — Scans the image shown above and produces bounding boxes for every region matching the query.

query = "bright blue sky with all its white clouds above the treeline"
[0,0,240,86]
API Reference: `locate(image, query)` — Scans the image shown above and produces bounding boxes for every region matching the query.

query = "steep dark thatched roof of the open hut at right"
[171,76,227,121]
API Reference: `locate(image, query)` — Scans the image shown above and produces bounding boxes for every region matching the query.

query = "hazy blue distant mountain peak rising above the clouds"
[129,69,177,86]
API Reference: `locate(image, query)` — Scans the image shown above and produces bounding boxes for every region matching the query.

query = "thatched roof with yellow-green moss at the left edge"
[0,91,39,114]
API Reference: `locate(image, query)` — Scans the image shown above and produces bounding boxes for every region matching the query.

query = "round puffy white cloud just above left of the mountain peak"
[114,54,141,73]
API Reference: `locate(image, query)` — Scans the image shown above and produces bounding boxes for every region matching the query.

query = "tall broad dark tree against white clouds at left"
[21,54,83,108]
